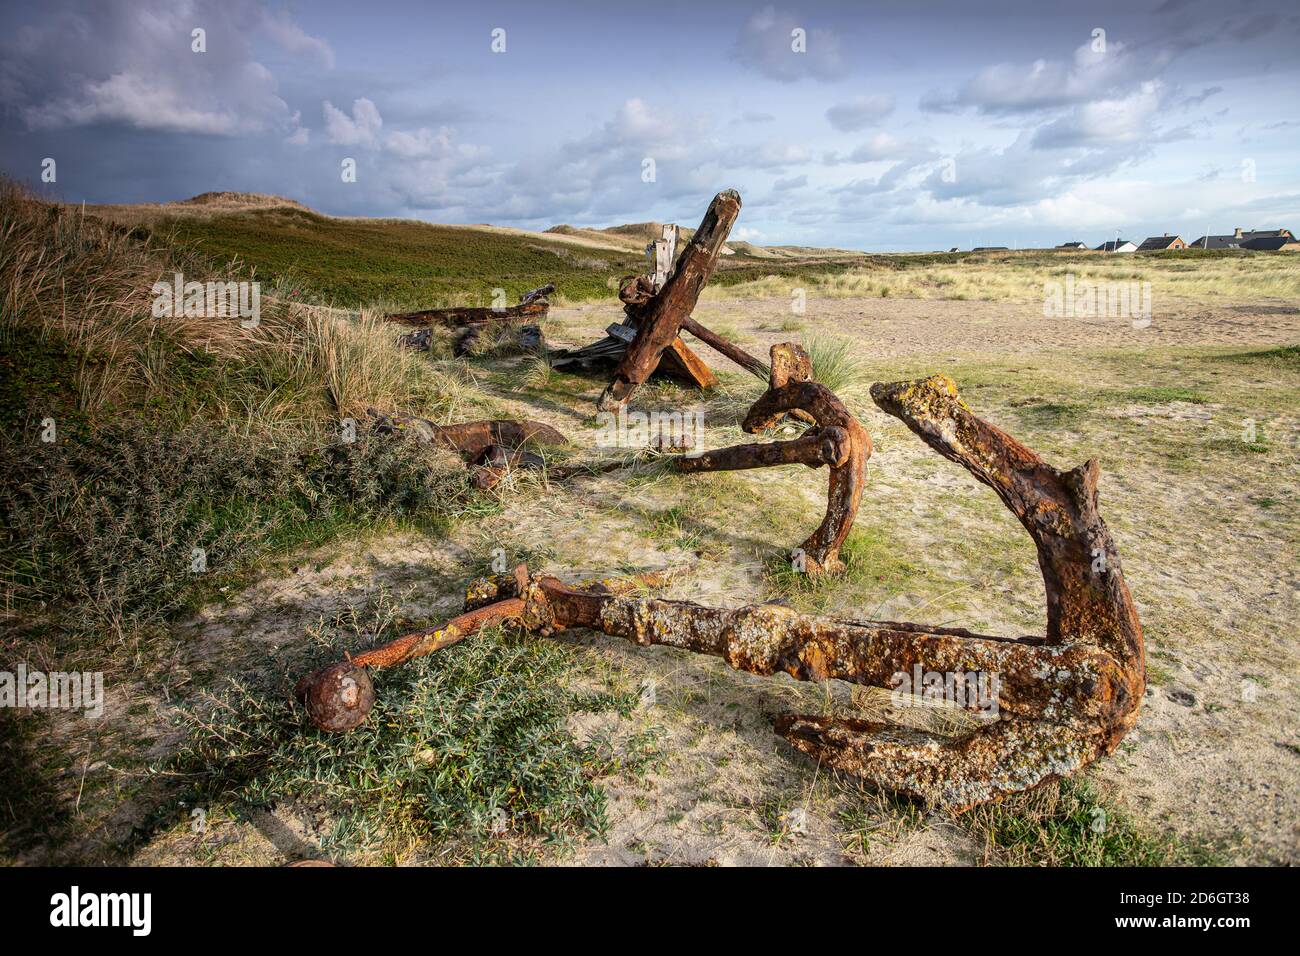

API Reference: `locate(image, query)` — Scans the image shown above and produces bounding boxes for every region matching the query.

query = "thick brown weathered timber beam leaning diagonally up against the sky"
[597,190,741,411]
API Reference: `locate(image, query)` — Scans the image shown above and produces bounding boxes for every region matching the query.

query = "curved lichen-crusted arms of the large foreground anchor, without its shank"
[777,376,1147,809]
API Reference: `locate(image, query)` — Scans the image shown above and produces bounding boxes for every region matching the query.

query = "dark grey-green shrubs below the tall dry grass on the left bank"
[0,421,473,670]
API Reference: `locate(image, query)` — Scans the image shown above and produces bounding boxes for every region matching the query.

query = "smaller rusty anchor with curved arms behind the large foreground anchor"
[675,342,871,575]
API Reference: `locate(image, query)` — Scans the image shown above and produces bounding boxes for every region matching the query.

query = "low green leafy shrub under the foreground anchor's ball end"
[168,598,657,864]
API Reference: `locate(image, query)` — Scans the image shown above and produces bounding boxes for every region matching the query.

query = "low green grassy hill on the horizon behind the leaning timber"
[87,193,867,310]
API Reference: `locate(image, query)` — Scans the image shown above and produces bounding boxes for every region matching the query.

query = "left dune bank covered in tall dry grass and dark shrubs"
[0,183,494,666]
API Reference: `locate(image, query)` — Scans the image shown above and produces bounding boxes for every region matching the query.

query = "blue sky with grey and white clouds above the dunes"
[0,0,1300,251]
